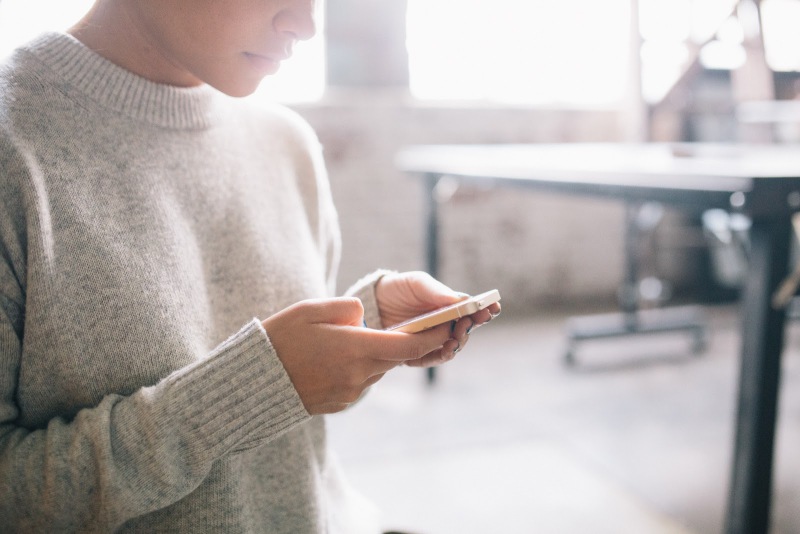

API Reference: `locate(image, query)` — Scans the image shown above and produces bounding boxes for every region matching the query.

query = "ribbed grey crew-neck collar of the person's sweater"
[27,32,221,129]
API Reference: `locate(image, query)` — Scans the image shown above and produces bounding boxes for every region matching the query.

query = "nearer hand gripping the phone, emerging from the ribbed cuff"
[262,297,452,415]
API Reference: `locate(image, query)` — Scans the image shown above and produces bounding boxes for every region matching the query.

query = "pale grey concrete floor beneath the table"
[329,306,800,534]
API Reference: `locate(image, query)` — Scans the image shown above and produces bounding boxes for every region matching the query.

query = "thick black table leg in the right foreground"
[725,218,792,534]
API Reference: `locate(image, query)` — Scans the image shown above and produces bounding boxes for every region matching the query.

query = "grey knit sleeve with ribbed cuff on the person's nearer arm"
[0,314,310,532]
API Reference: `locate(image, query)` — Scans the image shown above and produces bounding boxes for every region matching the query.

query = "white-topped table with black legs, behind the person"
[396,143,800,534]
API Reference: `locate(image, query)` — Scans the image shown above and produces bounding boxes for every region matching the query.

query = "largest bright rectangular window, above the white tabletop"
[407,0,631,107]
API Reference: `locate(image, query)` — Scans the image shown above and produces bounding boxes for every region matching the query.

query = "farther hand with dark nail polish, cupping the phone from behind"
[375,271,500,367]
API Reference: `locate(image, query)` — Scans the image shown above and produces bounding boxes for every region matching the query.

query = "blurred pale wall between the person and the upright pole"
[296,90,652,312]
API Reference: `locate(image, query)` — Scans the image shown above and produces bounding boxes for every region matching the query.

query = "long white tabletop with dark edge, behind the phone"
[396,143,800,217]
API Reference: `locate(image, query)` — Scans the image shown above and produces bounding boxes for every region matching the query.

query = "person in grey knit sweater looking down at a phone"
[0,0,500,534]
